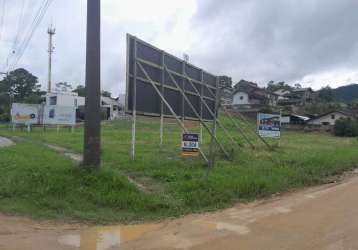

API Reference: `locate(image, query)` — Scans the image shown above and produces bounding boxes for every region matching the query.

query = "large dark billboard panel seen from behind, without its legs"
[126,35,218,121]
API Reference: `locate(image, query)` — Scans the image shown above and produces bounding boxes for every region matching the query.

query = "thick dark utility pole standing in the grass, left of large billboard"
[83,0,101,168]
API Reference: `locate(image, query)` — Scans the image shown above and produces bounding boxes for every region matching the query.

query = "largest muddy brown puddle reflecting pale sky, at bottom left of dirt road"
[58,224,162,250]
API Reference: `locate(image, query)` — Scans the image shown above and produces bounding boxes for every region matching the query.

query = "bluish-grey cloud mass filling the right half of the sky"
[193,0,358,88]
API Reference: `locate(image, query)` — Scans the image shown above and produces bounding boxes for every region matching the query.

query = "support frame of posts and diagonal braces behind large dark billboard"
[126,34,240,166]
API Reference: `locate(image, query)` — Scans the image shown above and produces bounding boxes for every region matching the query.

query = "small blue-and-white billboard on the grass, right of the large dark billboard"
[257,113,281,138]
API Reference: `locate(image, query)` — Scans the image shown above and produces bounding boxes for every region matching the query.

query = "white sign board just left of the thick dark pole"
[43,106,76,126]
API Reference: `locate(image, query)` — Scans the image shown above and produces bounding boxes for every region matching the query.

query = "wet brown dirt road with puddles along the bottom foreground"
[0,172,358,250]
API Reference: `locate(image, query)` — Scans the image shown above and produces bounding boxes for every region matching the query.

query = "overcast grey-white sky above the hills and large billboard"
[0,0,358,95]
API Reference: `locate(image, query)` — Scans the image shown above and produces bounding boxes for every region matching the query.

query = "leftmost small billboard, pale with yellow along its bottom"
[11,103,40,125]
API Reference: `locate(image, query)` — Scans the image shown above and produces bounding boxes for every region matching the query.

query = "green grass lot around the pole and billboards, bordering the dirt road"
[0,117,358,224]
